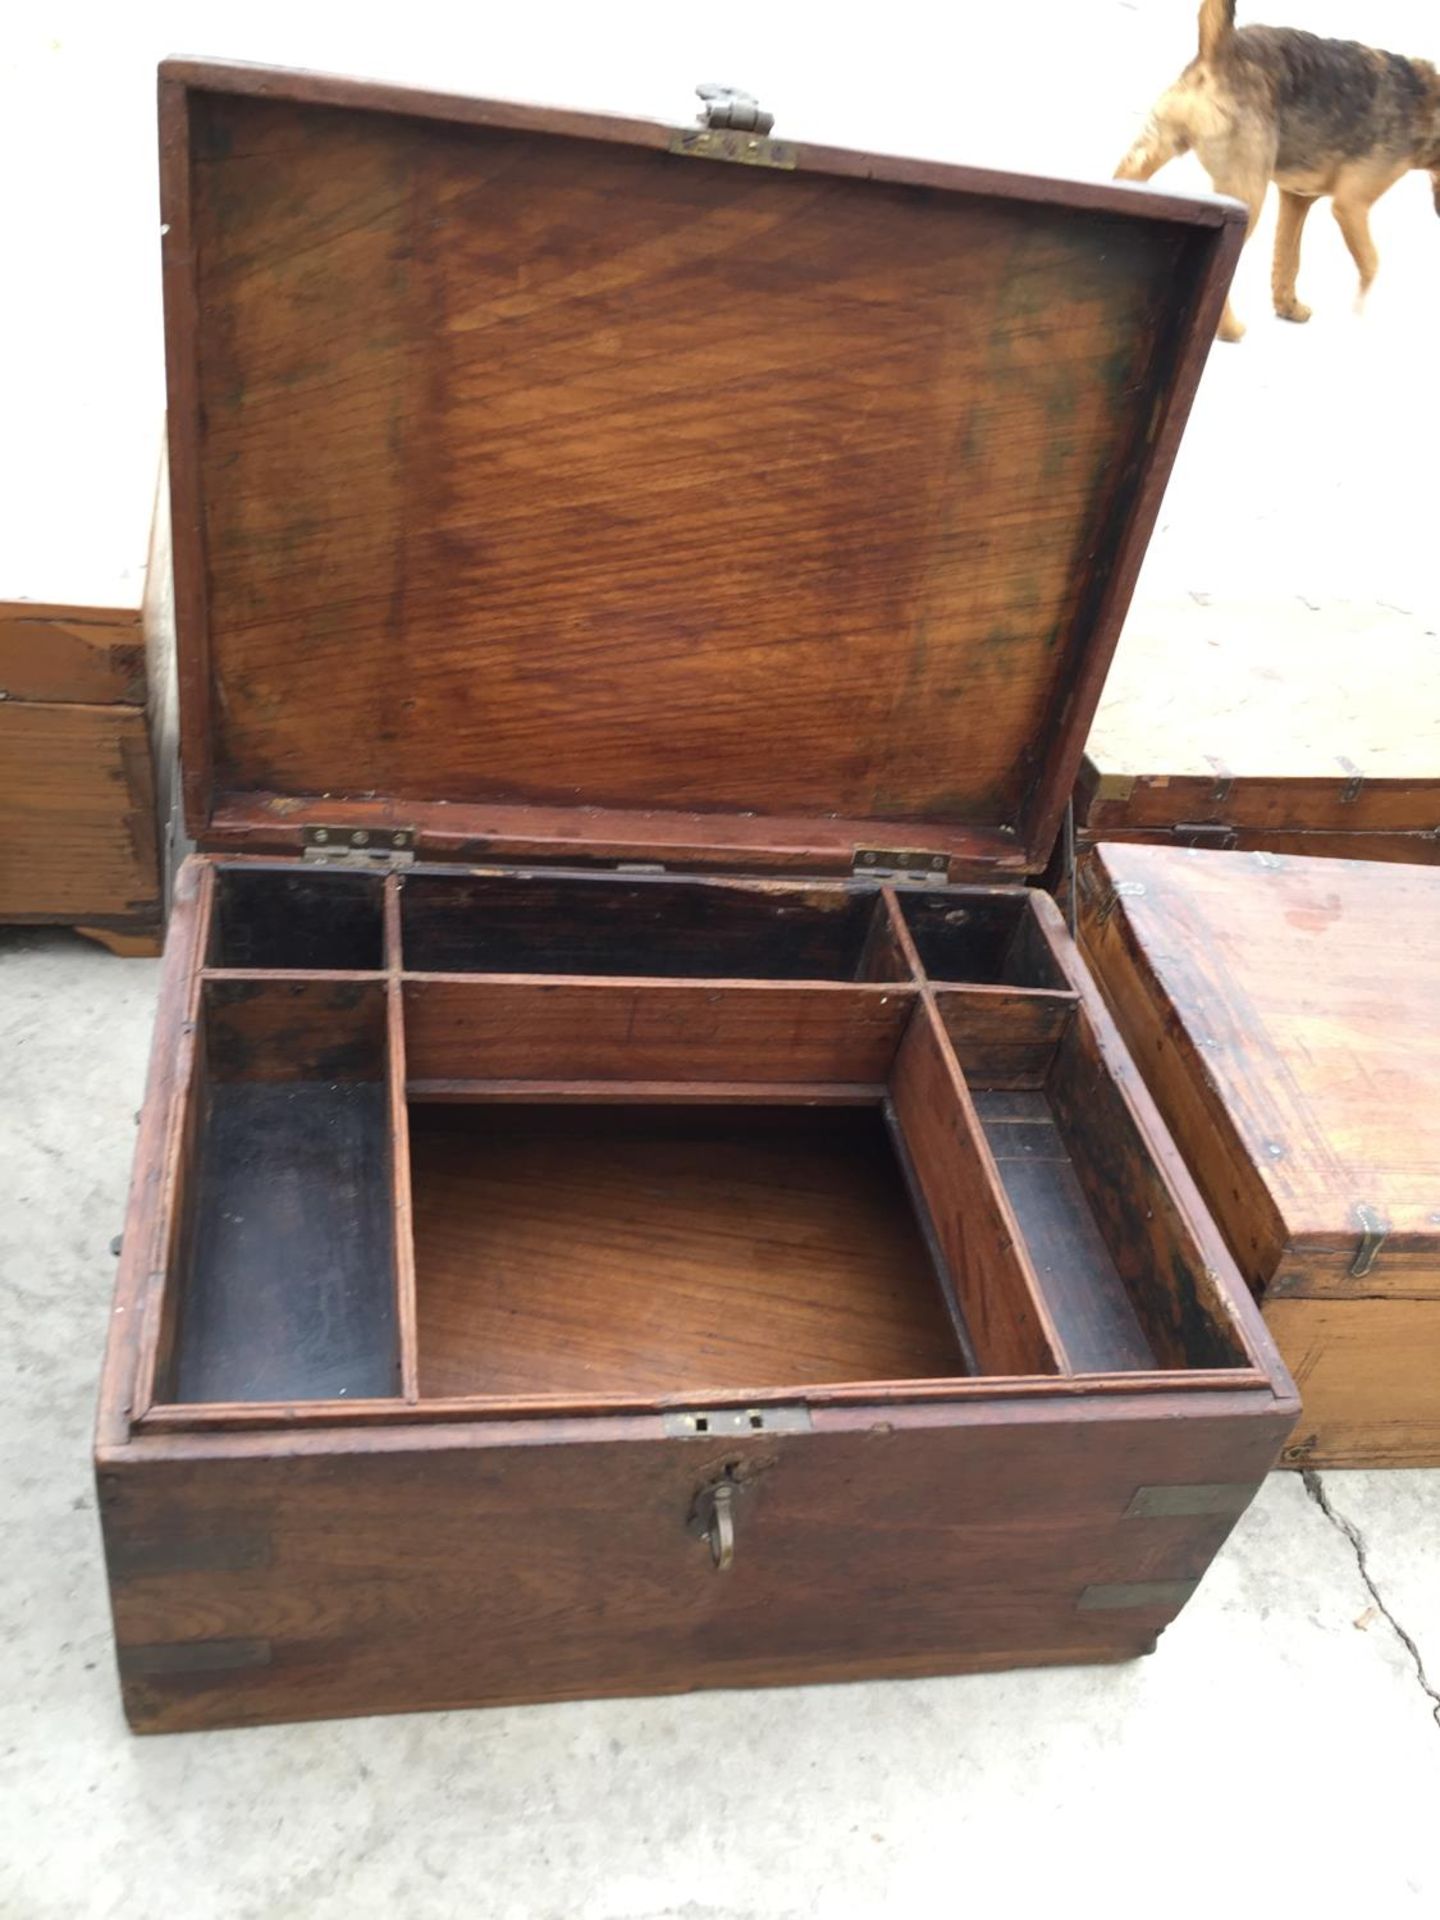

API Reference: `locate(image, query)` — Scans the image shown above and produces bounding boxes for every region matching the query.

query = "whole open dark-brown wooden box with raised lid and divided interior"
[98,65,1296,1730]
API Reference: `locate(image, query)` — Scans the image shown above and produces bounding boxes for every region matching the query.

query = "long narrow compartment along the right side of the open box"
[937,989,1250,1373]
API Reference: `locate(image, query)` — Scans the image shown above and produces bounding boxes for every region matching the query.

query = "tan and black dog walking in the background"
[1116,0,1440,340]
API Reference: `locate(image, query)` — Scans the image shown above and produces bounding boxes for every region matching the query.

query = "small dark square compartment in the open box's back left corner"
[209,862,384,972]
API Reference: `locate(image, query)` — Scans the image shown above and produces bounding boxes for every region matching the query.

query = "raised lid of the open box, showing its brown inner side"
[161,61,1242,877]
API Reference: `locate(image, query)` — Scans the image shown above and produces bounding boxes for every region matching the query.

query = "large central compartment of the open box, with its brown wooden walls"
[407,981,1058,1398]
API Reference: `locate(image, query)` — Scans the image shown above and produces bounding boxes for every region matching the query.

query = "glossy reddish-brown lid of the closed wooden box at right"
[1087,845,1440,1296]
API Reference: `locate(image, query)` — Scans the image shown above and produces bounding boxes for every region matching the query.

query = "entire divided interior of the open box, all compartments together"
[141,862,1248,1407]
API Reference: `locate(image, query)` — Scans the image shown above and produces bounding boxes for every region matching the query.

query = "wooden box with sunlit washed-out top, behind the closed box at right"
[1075,599,1440,864]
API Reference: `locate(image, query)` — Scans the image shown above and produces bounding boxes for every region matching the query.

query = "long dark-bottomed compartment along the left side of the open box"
[157,983,399,1404]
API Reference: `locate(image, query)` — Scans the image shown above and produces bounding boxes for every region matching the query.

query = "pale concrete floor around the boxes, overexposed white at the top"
[0,0,1440,1920]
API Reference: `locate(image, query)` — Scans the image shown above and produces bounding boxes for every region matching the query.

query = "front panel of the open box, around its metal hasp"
[100,1394,1288,1732]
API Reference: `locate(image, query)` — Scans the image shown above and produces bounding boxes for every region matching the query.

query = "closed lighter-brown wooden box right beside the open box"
[1079,845,1440,1467]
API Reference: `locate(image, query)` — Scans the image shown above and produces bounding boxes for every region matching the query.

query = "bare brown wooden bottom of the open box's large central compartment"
[411,1106,966,1396]
